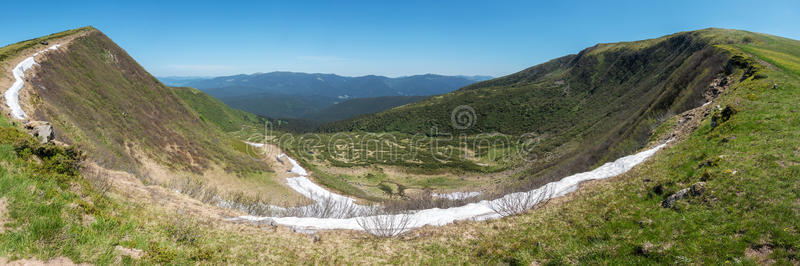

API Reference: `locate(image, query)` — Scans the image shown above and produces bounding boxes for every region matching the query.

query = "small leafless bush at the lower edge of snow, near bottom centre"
[356,210,414,237]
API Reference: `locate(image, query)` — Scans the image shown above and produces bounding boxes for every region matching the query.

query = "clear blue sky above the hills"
[0,0,800,76]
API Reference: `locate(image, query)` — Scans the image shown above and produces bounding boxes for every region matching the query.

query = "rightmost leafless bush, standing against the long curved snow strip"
[489,184,554,216]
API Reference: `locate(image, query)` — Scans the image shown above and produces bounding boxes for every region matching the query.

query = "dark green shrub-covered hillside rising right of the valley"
[321,29,759,190]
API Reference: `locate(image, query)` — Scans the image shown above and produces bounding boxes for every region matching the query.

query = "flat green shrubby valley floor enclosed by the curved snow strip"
[272,132,524,200]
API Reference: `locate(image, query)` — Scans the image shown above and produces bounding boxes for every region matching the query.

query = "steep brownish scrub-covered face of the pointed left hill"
[31,30,268,176]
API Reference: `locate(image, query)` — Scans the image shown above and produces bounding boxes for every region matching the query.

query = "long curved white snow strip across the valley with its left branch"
[233,143,666,233]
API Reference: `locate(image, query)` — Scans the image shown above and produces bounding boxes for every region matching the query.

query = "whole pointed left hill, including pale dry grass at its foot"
[0,28,306,208]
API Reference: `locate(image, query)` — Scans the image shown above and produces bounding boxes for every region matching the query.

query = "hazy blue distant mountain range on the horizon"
[160,72,492,121]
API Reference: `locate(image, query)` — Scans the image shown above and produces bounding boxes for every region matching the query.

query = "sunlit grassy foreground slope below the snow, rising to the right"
[0,27,800,264]
